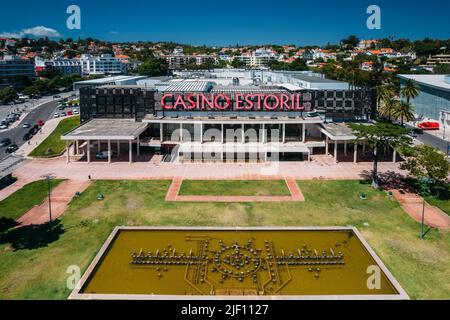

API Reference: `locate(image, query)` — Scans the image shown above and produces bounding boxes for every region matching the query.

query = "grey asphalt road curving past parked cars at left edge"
[0,101,58,160]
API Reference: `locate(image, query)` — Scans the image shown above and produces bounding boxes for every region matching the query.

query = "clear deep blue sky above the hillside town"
[0,0,450,45]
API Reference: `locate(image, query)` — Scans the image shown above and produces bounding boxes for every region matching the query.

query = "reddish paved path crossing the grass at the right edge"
[392,190,450,229]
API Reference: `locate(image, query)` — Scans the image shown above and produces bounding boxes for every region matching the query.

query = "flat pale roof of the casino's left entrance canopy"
[61,119,147,140]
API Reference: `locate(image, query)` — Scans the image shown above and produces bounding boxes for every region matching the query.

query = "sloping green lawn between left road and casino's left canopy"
[30,116,80,157]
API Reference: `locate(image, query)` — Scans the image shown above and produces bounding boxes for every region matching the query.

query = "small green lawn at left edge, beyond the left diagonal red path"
[0,180,63,219]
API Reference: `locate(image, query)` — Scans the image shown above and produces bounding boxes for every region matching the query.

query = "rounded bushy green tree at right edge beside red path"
[400,144,450,182]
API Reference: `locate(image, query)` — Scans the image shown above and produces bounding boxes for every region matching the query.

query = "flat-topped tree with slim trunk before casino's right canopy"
[349,121,411,188]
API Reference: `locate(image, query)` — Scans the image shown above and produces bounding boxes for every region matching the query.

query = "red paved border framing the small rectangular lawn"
[166,176,305,202]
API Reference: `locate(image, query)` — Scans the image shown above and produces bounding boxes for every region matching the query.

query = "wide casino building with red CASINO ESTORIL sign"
[62,69,375,162]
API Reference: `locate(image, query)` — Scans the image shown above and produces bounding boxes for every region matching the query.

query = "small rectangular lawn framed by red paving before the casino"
[179,180,290,196]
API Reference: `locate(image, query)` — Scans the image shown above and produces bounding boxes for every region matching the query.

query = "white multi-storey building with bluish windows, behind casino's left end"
[80,54,126,75]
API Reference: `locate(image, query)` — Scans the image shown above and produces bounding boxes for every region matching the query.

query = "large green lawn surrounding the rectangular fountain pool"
[0,181,450,299]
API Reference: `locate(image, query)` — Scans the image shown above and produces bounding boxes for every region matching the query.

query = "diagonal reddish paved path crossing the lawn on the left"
[17,180,90,226]
